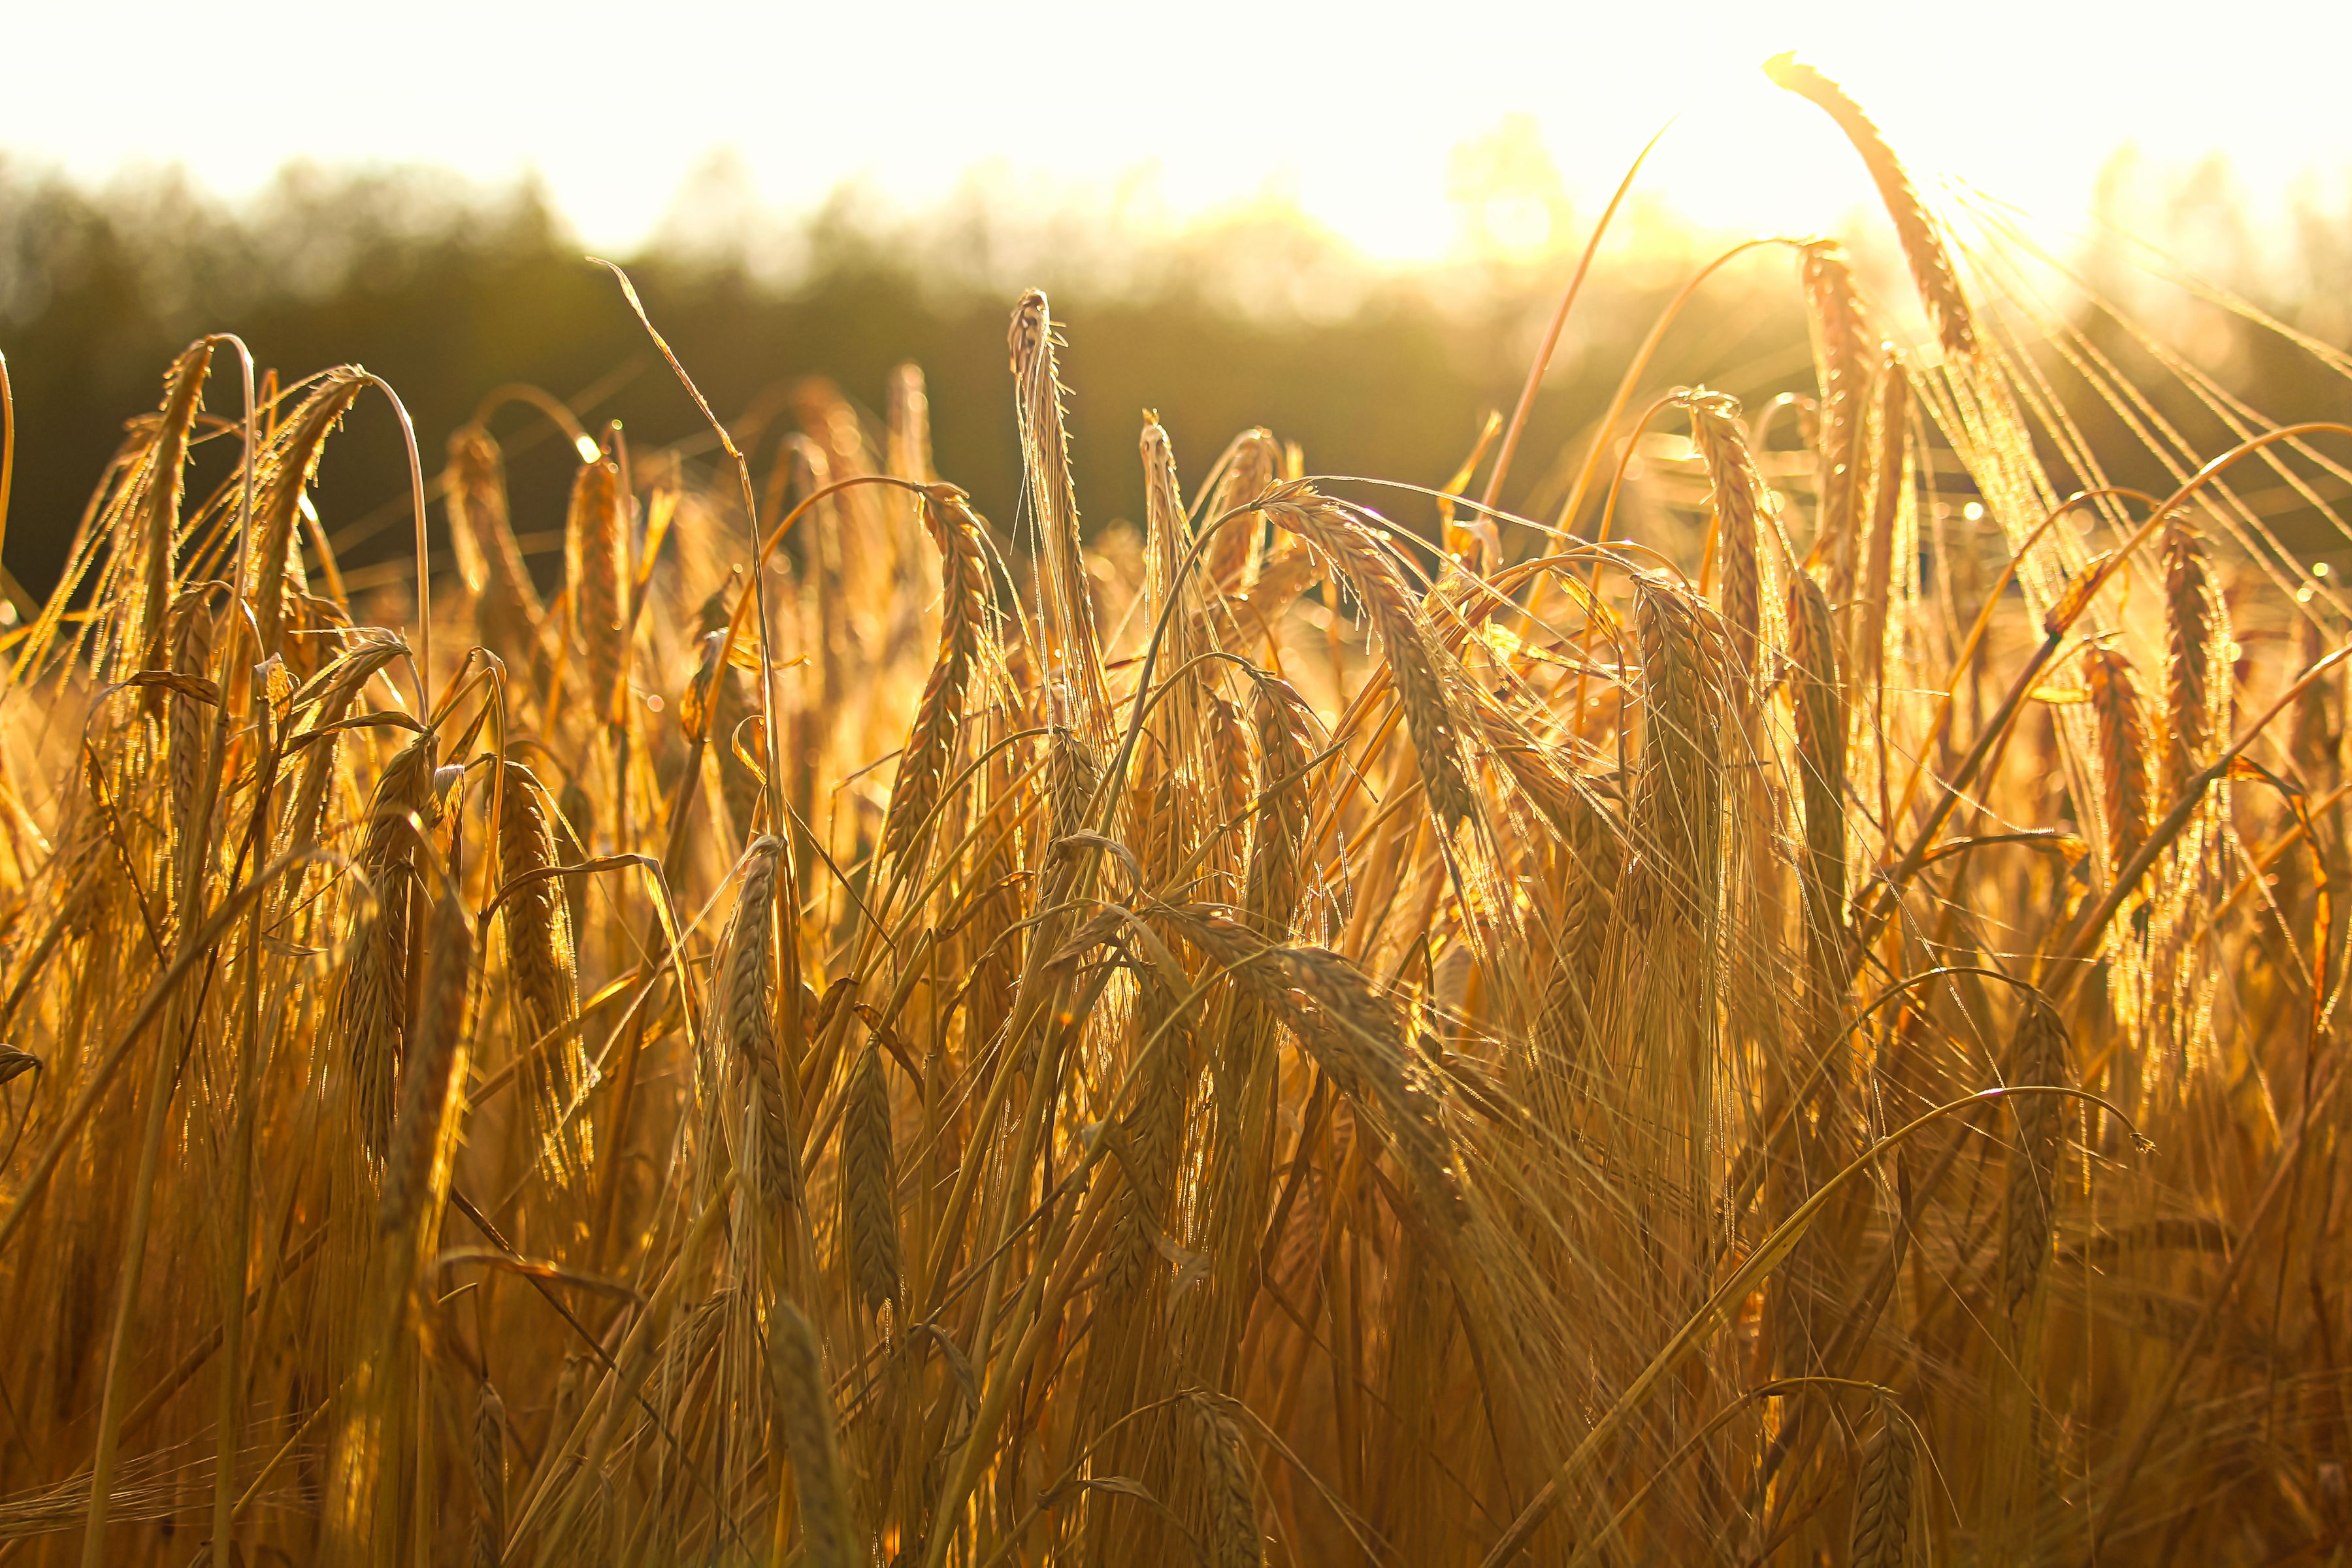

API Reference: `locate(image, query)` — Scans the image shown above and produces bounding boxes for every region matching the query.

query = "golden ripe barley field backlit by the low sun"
[0,59,2352,1568]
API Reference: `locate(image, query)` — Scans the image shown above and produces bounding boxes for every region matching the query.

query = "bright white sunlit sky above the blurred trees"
[0,0,2352,261]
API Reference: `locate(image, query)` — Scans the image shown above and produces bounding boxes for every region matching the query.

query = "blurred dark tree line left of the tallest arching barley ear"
[0,159,1806,593]
